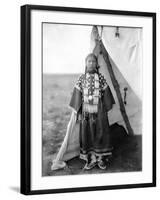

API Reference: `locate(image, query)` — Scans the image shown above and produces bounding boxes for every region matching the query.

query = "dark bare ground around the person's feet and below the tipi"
[43,135,142,176]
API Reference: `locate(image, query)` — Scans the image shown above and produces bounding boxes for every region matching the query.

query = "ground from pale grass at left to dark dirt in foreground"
[42,74,142,176]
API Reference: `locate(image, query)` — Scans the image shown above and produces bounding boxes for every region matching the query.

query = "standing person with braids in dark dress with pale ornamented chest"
[70,54,115,170]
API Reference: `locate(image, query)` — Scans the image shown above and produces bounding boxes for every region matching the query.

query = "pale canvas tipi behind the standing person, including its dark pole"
[51,26,142,170]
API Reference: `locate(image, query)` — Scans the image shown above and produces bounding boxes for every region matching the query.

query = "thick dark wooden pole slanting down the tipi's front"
[99,40,134,135]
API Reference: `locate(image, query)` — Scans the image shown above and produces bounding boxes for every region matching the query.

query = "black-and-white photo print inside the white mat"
[42,23,143,176]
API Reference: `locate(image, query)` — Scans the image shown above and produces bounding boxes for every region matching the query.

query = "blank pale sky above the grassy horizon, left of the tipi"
[43,23,92,73]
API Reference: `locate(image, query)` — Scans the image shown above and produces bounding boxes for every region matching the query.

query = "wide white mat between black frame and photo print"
[31,10,152,190]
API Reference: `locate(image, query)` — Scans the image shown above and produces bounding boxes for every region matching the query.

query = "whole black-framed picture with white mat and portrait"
[21,5,156,194]
